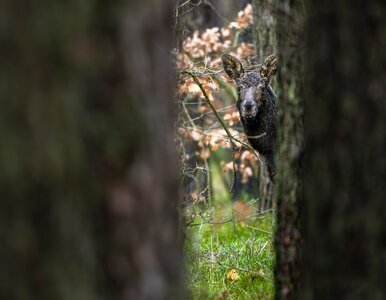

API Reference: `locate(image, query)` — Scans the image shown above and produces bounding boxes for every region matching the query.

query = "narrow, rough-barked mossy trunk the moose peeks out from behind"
[275,0,304,299]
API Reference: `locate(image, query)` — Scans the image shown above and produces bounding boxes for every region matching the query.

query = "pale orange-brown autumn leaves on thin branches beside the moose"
[173,5,259,205]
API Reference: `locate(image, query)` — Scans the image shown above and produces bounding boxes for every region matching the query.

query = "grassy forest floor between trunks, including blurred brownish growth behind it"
[184,165,275,299]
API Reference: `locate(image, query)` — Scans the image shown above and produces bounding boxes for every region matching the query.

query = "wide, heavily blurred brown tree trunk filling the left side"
[0,0,183,300]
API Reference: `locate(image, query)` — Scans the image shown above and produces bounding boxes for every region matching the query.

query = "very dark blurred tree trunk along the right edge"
[301,0,386,299]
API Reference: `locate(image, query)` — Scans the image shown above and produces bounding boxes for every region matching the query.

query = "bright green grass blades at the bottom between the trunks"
[185,212,274,299]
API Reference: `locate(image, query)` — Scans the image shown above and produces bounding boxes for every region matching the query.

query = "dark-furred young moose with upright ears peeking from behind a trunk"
[222,54,277,180]
